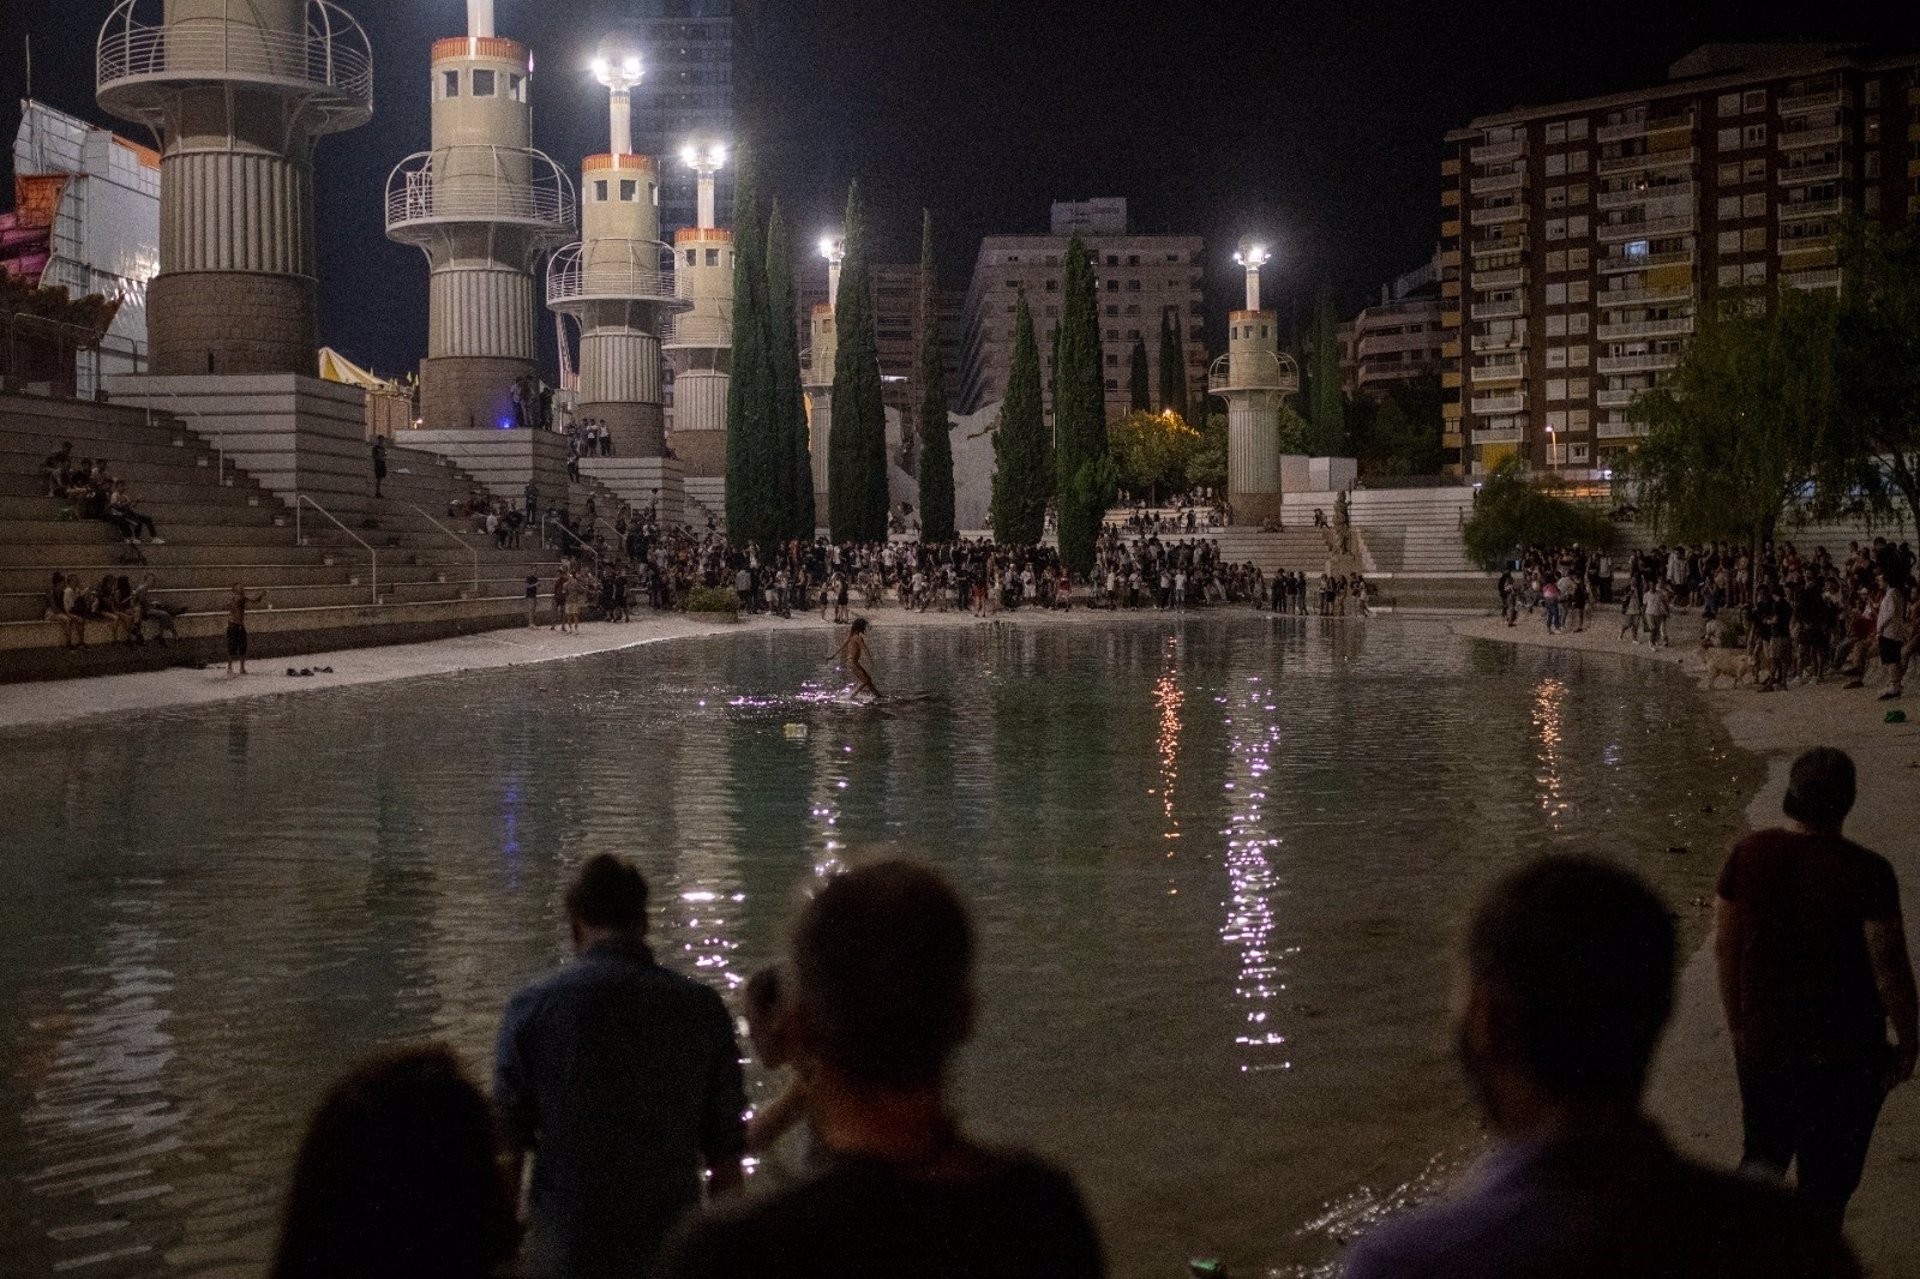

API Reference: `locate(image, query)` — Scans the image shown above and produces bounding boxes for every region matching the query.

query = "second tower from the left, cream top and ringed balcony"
[385,0,574,430]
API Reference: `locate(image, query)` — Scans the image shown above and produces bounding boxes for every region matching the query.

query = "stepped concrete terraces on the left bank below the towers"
[0,396,576,680]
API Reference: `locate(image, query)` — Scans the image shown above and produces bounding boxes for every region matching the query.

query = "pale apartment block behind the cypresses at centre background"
[958,198,1208,415]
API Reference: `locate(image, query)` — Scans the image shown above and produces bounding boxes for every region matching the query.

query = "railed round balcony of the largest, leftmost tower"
[94,0,372,134]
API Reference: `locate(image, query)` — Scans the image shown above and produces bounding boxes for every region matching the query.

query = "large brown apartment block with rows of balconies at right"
[1440,44,1920,482]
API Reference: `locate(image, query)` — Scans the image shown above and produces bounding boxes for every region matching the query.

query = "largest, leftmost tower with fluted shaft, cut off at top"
[96,0,372,374]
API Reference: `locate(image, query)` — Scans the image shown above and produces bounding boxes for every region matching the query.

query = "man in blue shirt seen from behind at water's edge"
[493,855,747,1279]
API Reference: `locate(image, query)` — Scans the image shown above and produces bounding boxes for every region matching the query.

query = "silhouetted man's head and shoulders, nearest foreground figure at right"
[1346,857,1860,1279]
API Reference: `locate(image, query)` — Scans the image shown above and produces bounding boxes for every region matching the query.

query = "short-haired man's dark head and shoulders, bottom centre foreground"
[660,860,1104,1279]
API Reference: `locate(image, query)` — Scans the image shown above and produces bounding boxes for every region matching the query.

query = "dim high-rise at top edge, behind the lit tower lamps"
[626,0,735,232]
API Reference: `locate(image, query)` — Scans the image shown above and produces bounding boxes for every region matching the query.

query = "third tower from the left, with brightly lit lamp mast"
[547,38,684,459]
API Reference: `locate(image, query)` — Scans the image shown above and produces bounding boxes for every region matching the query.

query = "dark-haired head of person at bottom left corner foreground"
[273,1047,520,1279]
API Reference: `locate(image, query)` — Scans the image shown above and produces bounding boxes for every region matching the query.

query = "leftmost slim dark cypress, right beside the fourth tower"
[726,148,774,543]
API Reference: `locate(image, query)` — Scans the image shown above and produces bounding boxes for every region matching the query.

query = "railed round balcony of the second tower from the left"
[386,144,574,244]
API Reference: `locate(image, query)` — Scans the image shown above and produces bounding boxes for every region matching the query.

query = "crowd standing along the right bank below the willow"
[1500,538,1920,701]
